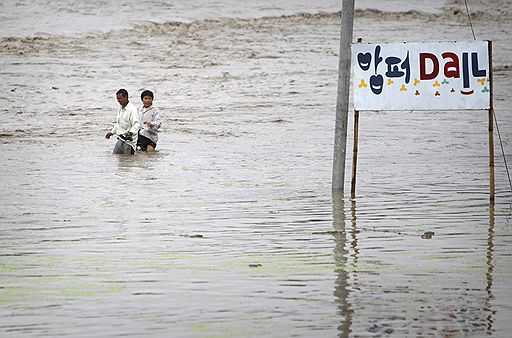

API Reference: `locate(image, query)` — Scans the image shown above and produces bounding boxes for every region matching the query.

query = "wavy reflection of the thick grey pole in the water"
[332,193,354,337]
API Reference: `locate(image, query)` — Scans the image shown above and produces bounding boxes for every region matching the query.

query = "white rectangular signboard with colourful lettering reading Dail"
[352,41,491,110]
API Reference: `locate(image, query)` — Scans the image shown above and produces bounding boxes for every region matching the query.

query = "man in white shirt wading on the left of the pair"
[105,89,140,155]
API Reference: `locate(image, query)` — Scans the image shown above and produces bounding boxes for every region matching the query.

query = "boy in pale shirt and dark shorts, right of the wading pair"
[137,90,162,152]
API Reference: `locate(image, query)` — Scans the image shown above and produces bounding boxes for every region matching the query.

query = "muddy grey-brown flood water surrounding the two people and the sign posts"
[0,0,512,337]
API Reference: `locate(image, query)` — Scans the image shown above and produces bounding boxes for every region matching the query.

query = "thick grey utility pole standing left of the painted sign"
[332,0,355,195]
